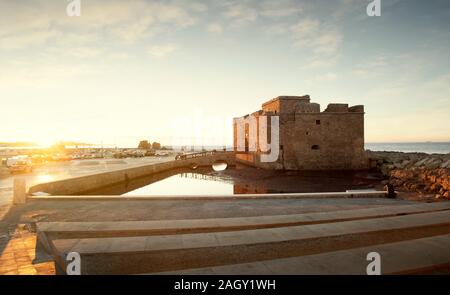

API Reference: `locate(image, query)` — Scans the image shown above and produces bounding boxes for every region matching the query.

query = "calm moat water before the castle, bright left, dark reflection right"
[81,165,381,196]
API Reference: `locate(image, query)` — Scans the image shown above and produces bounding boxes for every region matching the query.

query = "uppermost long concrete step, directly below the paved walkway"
[37,202,450,253]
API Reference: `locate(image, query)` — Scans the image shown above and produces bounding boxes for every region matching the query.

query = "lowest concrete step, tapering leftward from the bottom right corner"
[159,235,450,275]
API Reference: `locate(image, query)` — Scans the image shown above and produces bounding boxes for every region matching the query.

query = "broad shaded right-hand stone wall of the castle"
[279,112,368,170]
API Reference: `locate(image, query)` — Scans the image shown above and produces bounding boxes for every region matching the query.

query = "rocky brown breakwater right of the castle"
[368,151,450,199]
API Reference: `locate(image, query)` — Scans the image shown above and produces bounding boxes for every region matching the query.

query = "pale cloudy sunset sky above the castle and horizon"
[0,0,450,146]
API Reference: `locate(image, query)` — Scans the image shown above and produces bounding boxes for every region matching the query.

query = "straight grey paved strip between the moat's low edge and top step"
[5,198,417,228]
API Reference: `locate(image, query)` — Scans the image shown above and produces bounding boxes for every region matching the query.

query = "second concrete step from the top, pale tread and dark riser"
[53,211,450,274]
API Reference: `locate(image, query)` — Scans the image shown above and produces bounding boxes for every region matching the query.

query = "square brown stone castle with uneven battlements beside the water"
[234,95,369,170]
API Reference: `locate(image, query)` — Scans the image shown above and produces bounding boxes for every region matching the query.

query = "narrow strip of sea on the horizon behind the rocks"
[365,142,450,154]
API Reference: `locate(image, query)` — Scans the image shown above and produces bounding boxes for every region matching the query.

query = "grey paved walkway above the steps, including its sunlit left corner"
[0,198,416,274]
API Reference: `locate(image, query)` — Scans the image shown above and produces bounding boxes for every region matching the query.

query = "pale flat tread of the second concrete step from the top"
[54,211,450,254]
